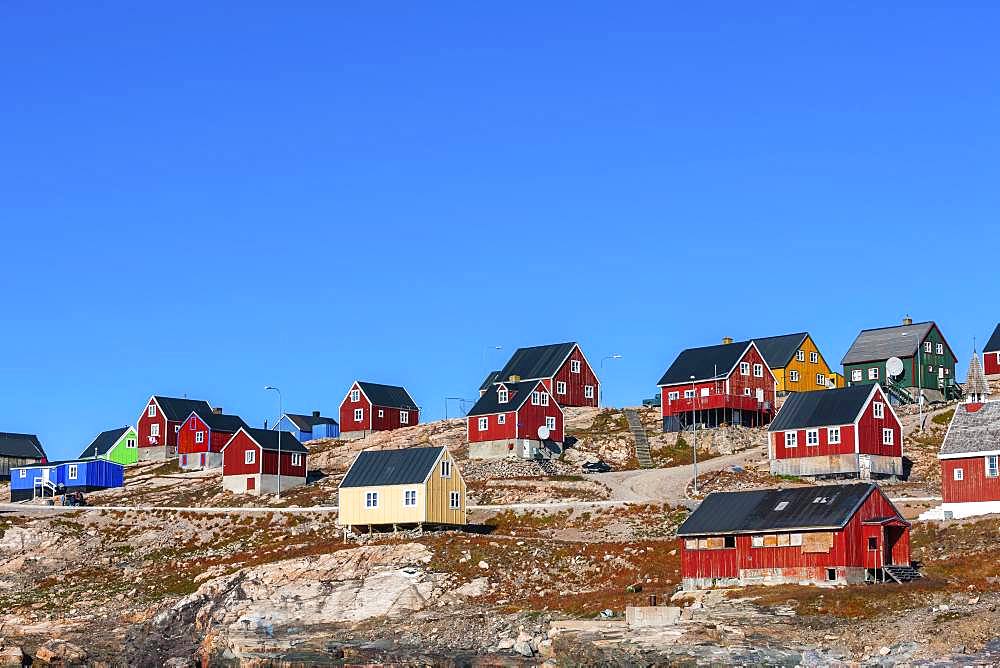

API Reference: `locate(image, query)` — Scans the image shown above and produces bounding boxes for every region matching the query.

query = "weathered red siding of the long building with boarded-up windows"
[679,488,910,580]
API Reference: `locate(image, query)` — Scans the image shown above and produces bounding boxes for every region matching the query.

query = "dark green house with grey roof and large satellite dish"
[841,317,961,403]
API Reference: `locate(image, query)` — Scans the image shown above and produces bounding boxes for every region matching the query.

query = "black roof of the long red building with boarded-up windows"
[677,483,876,536]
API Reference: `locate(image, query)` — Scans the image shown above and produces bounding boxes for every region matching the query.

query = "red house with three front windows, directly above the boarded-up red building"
[768,383,903,479]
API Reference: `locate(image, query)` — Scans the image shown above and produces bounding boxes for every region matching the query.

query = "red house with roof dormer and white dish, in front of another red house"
[466,380,563,459]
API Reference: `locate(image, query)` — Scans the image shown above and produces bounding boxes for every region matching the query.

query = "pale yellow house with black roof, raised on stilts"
[337,447,468,531]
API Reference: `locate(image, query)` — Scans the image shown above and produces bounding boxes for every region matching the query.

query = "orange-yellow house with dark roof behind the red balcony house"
[753,332,844,394]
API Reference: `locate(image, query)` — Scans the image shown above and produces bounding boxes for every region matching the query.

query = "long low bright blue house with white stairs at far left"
[10,459,125,501]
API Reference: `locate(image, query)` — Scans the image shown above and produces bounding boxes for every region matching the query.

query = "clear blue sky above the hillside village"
[0,1,1000,457]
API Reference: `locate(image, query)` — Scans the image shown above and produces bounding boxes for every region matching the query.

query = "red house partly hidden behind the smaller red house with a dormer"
[479,341,601,406]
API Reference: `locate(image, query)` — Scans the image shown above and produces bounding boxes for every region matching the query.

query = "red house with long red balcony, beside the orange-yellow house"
[657,341,776,431]
